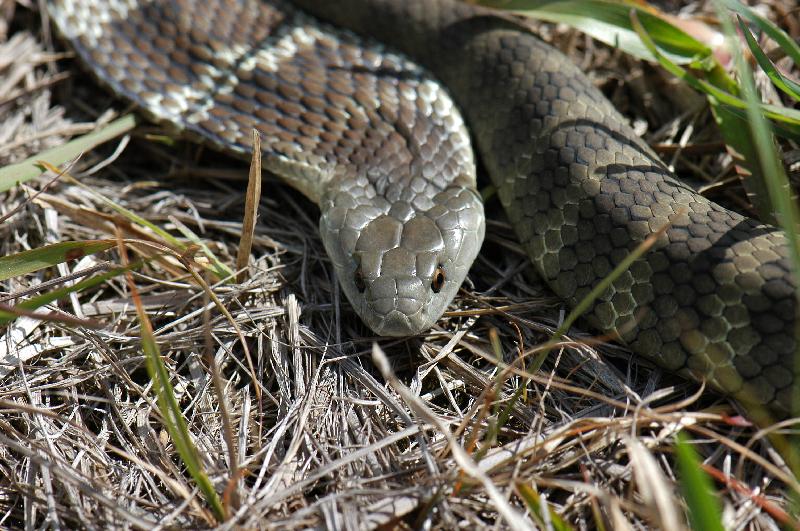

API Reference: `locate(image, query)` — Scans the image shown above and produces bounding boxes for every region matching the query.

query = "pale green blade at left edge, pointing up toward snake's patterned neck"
[0,114,136,192]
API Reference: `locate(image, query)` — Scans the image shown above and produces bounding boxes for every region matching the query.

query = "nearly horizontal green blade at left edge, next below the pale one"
[0,240,116,282]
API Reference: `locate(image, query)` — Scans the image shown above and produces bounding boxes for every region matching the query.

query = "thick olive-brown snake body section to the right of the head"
[295,0,799,417]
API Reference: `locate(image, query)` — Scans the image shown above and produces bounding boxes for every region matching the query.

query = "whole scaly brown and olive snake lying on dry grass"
[48,0,800,418]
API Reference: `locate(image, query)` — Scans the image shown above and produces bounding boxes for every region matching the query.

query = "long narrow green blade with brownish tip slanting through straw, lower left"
[120,246,226,521]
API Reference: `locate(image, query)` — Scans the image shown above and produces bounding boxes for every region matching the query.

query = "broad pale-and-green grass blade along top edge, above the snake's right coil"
[481,0,711,64]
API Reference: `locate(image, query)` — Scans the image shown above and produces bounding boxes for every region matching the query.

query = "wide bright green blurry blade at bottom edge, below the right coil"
[675,432,725,531]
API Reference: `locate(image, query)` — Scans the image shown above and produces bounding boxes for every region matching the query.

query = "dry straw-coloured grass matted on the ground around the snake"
[0,2,798,529]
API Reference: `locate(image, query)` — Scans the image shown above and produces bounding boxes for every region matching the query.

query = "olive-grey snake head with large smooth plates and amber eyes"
[320,177,485,336]
